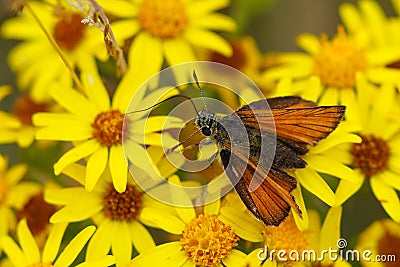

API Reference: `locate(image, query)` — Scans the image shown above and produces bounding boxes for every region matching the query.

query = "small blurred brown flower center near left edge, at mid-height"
[13,96,49,125]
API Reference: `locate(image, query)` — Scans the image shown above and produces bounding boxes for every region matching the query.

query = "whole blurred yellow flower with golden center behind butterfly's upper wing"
[264,22,400,105]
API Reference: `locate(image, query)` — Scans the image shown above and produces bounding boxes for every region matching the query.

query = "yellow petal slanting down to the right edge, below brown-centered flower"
[370,176,400,223]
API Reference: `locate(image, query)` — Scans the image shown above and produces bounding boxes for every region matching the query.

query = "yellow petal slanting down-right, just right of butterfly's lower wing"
[296,167,336,206]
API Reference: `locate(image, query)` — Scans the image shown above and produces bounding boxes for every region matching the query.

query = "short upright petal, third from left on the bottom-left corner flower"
[42,222,68,262]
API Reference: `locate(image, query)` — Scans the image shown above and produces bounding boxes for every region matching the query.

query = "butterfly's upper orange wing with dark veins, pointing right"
[236,97,345,147]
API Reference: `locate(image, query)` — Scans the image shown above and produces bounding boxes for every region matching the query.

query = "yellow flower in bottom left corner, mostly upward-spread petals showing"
[0,219,115,267]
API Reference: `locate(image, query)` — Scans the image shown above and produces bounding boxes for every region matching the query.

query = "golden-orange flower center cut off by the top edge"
[139,0,188,39]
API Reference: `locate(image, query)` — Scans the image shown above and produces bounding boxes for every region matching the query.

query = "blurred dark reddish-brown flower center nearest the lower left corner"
[18,193,56,235]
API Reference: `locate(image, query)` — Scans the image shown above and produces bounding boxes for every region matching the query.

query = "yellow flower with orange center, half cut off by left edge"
[0,155,41,239]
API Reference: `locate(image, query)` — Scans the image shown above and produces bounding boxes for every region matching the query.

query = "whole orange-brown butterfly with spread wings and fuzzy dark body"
[193,72,345,226]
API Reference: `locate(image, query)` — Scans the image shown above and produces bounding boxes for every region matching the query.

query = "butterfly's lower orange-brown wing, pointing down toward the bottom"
[220,149,301,226]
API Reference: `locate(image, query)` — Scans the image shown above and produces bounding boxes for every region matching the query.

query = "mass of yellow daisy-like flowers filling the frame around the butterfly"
[0,0,400,267]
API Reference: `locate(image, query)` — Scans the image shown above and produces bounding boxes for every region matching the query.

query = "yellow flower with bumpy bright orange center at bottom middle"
[128,176,245,267]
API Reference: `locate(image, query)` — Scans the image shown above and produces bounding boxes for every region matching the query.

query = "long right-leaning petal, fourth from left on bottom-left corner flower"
[54,225,96,267]
